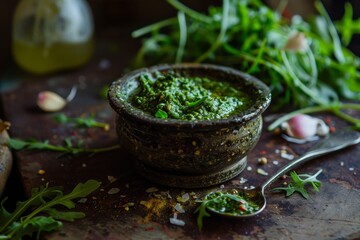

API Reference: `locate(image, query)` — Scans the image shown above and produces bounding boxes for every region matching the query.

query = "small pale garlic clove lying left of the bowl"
[37,91,67,112]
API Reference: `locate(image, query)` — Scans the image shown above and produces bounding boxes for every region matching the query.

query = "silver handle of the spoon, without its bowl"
[261,130,360,191]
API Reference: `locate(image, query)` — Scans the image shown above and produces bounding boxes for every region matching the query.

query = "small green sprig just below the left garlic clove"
[54,114,109,131]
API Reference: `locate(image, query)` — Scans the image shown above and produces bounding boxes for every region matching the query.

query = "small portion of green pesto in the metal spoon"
[205,191,260,216]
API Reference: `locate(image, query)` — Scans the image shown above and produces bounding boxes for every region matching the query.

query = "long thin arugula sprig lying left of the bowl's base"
[7,138,120,155]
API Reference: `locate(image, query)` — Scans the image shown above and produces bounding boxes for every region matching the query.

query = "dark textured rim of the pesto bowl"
[108,63,271,128]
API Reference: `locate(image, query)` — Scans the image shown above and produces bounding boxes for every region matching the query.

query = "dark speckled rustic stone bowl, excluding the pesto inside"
[108,64,271,188]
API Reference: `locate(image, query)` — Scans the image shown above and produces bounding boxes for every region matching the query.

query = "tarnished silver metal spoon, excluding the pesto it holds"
[208,130,360,218]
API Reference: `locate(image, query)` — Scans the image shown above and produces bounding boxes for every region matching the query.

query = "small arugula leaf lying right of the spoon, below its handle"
[272,169,322,199]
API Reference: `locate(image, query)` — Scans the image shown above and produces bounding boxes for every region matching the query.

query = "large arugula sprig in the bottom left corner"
[0,180,101,239]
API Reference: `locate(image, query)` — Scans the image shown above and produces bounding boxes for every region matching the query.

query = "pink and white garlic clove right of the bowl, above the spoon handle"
[281,114,329,139]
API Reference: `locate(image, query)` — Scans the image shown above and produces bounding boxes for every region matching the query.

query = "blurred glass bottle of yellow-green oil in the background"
[12,0,94,74]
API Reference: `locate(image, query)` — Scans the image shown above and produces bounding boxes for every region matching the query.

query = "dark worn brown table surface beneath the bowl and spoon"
[0,32,360,239]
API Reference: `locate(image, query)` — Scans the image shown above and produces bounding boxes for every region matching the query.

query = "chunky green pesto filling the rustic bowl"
[132,71,249,121]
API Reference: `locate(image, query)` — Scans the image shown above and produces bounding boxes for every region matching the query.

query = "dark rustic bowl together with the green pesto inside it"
[108,64,271,188]
